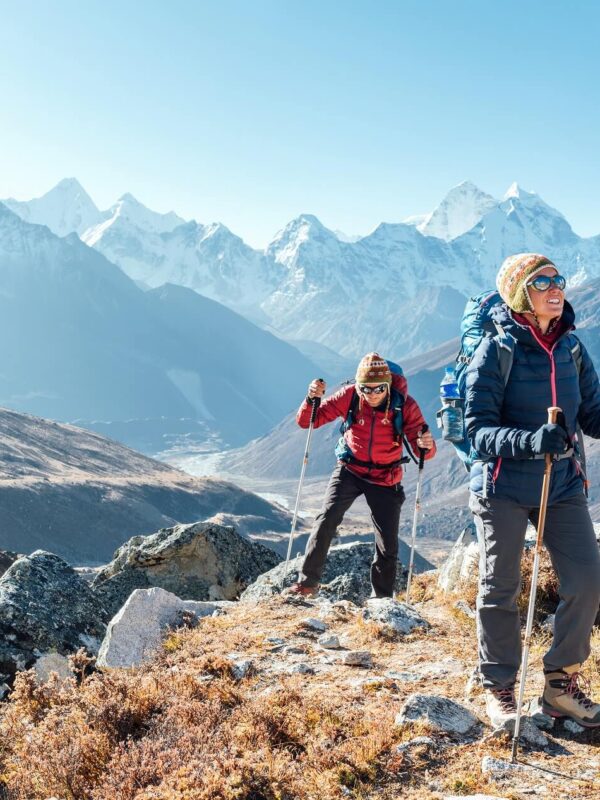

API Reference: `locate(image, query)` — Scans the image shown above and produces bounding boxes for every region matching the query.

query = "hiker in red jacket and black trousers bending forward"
[288,353,435,597]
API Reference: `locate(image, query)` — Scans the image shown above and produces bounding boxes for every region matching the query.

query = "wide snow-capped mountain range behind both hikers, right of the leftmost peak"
[8,181,600,359]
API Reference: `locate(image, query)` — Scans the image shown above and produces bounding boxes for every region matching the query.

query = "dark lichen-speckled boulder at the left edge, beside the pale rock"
[0,550,110,683]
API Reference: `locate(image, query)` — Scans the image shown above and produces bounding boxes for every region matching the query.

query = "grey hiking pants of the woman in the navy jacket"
[469,494,600,688]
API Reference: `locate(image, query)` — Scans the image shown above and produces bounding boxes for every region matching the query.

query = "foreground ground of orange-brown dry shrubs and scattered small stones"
[0,579,600,800]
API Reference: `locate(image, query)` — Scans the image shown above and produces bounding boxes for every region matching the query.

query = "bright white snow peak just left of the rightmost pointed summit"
[417,181,498,242]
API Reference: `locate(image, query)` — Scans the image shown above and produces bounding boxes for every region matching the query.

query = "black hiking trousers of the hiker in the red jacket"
[299,464,405,597]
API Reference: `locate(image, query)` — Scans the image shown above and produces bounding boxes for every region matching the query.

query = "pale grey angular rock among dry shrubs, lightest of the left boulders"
[97,587,231,667]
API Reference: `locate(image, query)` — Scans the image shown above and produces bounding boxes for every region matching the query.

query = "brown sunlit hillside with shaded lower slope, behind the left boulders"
[0,409,289,564]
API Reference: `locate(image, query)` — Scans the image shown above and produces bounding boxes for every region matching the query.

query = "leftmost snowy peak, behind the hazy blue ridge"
[1,178,102,241]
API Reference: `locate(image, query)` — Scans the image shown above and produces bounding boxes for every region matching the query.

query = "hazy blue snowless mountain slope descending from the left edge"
[0,204,319,449]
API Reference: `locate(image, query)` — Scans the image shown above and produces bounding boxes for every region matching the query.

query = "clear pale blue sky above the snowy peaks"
[0,0,600,245]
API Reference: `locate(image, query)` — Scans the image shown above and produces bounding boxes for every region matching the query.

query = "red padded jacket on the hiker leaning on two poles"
[296,378,436,486]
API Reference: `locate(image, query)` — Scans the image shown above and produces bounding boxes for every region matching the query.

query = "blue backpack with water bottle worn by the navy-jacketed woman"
[437,291,585,477]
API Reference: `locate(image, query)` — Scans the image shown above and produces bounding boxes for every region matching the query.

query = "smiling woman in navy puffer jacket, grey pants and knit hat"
[465,253,600,727]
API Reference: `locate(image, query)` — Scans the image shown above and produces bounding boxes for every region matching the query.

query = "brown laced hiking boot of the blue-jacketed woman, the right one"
[542,664,600,728]
